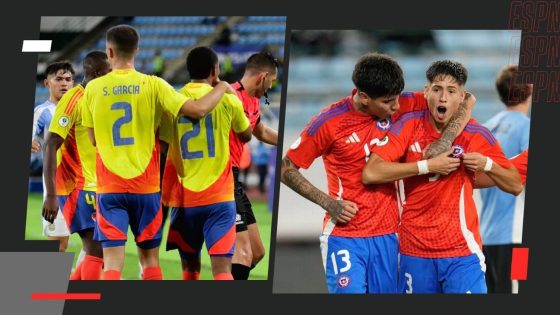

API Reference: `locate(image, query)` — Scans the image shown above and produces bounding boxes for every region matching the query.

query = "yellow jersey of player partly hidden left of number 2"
[49,84,96,196]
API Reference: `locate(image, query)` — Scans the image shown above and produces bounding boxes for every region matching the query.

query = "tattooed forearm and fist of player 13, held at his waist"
[280,157,358,224]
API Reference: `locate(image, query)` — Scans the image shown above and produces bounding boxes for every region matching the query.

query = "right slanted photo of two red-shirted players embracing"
[273,30,532,294]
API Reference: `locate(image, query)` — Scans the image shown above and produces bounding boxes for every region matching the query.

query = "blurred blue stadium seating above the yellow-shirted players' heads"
[35,16,286,105]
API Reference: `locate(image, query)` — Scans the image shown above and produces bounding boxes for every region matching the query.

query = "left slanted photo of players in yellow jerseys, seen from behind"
[25,16,286,280]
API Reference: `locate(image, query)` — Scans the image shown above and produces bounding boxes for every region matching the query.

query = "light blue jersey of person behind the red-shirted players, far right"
[480,111,530,245]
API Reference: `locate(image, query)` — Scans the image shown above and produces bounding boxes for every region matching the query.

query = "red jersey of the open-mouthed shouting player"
[373,110,511,258]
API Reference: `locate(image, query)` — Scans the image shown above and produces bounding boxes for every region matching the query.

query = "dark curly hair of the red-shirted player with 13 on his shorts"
[352,53,404,98]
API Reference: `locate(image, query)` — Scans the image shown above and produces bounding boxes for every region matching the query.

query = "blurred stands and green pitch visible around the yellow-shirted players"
[26,16,286,279]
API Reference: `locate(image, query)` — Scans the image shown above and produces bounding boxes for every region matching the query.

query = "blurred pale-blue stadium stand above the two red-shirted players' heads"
[287,30,521,123]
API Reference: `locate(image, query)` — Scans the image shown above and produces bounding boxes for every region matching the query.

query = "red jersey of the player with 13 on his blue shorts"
[286,90,426,237]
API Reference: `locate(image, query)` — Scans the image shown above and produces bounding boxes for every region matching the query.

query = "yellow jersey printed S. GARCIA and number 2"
[83,69,188,193]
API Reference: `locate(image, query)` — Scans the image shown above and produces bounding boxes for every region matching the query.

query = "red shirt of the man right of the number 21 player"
[229,82,261,167]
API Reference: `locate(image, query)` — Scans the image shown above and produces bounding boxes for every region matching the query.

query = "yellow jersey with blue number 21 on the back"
[160,83,249,207]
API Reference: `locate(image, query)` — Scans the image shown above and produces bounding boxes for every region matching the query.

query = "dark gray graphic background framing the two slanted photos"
[0,0,560,315]
